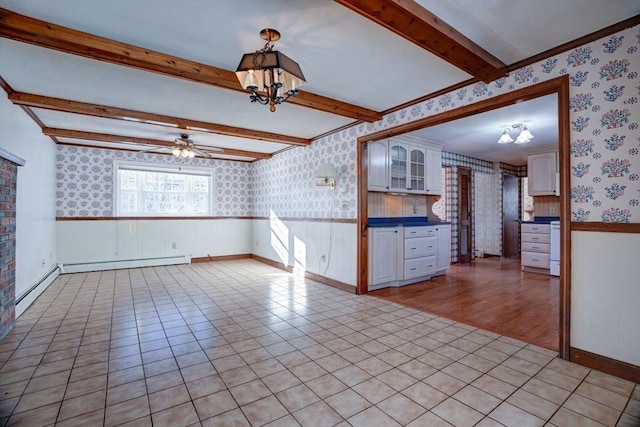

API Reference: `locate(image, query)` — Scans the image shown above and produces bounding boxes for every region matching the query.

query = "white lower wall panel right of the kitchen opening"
[571,231,640,366]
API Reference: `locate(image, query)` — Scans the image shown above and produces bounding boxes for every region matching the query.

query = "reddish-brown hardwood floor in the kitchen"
[369,257,560,351]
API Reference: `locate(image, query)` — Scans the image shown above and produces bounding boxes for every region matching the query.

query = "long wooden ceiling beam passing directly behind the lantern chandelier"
[0,8,382,122]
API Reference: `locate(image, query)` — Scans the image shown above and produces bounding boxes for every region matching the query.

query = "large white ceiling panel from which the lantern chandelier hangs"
[3,0,470,111]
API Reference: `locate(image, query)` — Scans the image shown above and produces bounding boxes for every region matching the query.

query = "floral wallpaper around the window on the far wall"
[56,145,252,217]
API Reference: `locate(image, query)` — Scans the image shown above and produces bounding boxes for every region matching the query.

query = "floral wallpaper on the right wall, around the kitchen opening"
[255,26,640,222]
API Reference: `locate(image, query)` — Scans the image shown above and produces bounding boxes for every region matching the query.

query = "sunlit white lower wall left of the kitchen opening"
[251,221,357,287]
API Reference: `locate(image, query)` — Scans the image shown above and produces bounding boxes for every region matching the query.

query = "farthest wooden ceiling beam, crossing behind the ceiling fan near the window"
[42,127,271,159]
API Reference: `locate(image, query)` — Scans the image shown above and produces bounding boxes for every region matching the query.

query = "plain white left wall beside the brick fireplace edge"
[0,91,57,296]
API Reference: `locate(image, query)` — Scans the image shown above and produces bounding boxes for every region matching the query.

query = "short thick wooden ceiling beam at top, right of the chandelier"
[335,0,507,83]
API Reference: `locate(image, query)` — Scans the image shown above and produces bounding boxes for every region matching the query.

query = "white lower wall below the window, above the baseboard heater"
[57,218,251,264]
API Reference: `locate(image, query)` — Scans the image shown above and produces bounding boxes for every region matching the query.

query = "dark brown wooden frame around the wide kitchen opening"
[356,75,571,360]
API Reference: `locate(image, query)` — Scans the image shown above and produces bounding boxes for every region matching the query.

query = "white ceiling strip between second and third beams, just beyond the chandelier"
[0,39,353,138]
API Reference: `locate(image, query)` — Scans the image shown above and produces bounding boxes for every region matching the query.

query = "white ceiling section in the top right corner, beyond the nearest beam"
[416,0,640,64]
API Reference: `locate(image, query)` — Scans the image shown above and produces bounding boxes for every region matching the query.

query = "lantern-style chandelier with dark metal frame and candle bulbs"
[236,28,306,112]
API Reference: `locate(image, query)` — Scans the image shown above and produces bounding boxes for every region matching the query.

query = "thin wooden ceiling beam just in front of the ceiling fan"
[8,92,311,146]
